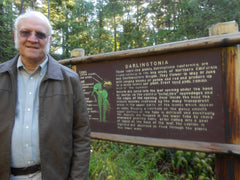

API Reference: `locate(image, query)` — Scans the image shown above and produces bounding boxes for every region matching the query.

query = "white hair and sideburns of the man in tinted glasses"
[14,8,52,53]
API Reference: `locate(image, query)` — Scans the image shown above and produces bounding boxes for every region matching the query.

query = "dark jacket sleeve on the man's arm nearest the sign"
[69,76,91,180]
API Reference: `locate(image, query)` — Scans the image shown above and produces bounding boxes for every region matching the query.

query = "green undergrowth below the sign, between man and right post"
[89,140,216,180]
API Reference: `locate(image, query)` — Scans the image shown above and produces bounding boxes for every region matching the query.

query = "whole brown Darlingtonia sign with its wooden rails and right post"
[60,26,240,179]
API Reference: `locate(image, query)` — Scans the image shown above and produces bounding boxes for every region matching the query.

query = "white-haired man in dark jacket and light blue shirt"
[0,10,90,180]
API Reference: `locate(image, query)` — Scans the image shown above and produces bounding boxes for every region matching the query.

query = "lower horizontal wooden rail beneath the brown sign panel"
[91,132,240,155]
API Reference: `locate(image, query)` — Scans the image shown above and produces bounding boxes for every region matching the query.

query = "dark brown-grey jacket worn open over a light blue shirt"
[0,56,90,180]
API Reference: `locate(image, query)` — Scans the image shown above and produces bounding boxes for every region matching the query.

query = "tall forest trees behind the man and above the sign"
[0,0,240,61]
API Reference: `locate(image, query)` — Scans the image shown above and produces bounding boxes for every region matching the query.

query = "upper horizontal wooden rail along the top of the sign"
[59,32,240,65]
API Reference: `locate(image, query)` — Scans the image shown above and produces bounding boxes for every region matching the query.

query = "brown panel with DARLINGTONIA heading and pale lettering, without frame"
[76,48,225,143]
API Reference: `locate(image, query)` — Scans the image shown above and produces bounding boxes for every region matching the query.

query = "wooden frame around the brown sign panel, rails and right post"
[60,32,240,179]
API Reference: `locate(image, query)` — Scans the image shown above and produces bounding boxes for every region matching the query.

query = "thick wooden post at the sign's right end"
[209,21,240,180]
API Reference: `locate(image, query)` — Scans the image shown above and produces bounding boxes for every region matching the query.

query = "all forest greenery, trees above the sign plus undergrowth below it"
[0,0,240,179]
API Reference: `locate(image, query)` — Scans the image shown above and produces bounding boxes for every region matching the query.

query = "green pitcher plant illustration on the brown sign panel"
[91,83,110,122]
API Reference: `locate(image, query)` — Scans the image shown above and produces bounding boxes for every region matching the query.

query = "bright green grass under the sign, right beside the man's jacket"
[89,141,160,180]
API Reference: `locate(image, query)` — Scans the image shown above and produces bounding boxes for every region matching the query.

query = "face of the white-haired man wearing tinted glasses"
[15,17,51,61]
